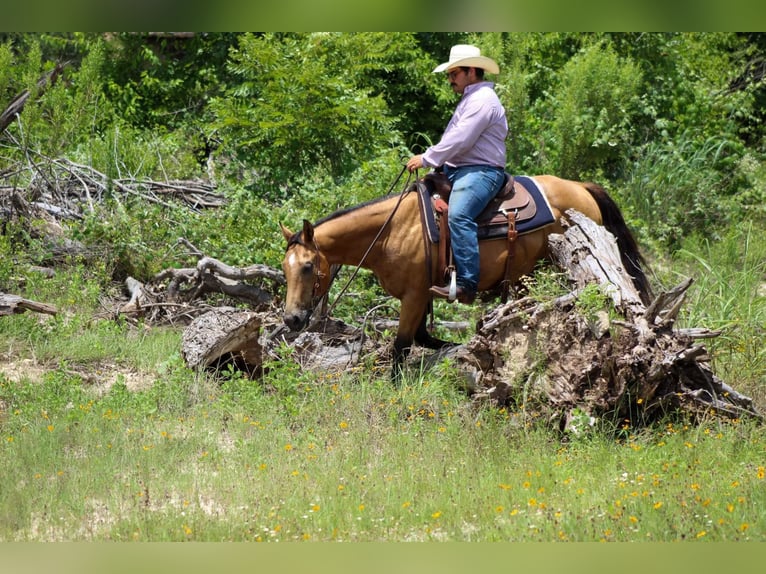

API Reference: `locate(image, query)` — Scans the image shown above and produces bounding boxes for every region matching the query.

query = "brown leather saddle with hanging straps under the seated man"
[420,172,547,302]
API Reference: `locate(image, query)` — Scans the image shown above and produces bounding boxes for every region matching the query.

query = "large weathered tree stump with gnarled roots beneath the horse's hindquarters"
[440,212,762,429]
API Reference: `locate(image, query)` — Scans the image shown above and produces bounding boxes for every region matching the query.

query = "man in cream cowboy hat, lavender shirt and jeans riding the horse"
[407,44,508,304]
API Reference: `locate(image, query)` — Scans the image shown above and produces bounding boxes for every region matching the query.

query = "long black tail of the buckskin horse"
[583,182,653,305]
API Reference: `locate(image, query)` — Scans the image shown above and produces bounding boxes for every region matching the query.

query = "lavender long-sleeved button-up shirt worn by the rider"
[423,82,508,168]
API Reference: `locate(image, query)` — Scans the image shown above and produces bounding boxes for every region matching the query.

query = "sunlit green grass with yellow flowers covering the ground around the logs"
[0,222,766,541]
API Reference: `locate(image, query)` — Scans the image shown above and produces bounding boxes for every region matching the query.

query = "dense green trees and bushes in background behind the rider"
[0,33,766,253]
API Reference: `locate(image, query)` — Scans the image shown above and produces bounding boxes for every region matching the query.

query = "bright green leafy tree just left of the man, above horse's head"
[207,33,404,191]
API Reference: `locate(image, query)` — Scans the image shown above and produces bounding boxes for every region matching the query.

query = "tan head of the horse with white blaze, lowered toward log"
[280,219,330,331]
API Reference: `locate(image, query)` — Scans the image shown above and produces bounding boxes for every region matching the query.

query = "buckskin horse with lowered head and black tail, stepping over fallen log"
[280,175,651,377]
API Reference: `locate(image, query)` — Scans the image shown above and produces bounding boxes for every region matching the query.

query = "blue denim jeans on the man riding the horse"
[444,165,505,293]
